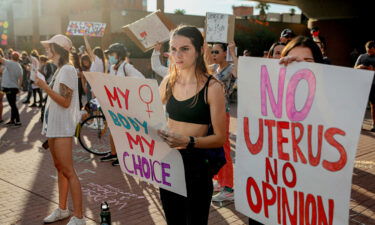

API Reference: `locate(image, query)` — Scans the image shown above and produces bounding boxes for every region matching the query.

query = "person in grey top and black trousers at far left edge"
[0,51,22,127]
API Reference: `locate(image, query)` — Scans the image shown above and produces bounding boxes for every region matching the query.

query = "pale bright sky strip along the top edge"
[147,0,301,16]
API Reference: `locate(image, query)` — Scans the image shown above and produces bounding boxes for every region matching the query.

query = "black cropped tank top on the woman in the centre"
[166,76,212,125]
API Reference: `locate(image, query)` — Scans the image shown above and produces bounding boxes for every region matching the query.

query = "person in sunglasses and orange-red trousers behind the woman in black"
[211,42,237,202]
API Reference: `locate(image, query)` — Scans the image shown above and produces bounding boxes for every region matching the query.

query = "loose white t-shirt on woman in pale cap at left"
[42,65,80,138]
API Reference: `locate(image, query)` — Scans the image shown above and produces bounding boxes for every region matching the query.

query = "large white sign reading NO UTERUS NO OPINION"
[235,57,373,225]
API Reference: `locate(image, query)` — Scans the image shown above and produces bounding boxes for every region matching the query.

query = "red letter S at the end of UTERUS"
[323,128,348,172]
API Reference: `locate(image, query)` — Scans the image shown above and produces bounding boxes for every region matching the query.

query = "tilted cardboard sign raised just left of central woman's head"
[123,11,175,52]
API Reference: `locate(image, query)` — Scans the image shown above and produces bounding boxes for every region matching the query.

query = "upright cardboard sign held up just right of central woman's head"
[205,13,235,43]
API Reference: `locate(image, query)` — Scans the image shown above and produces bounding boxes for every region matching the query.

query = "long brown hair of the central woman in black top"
[162,25,207,106]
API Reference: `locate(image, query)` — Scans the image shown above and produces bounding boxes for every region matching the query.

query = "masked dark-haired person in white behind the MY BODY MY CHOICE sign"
[100,43,144,166]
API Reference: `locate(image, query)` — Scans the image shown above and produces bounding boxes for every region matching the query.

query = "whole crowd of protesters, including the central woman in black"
[0,22,375,225]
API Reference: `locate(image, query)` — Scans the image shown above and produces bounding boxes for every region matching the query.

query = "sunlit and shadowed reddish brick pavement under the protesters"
[0,94,375,225]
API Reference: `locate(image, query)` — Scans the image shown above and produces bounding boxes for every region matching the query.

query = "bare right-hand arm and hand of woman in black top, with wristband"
[158,81,226,148]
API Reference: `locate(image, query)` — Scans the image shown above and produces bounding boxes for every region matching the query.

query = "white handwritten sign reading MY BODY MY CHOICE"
[84,72,186,196]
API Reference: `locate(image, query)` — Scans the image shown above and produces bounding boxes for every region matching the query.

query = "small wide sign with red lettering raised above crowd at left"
[66,21,107,37]
